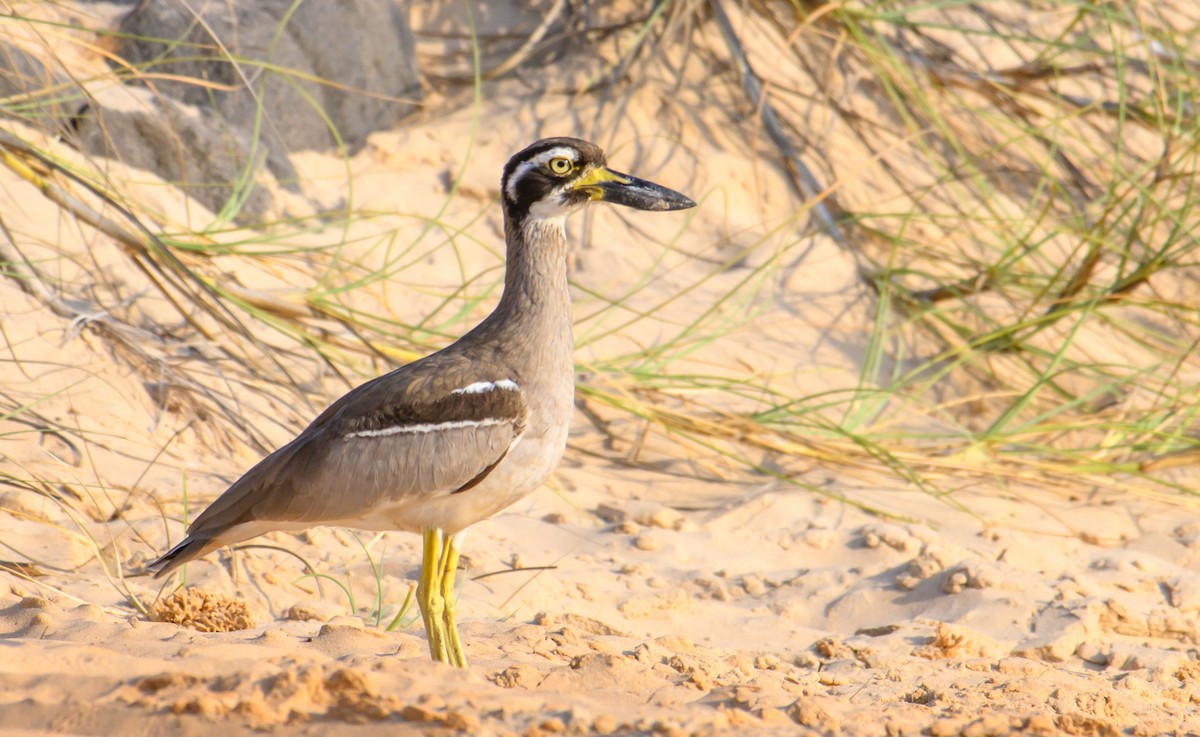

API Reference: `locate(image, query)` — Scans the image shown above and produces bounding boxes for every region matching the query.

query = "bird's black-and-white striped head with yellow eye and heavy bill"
[500,138,696,221]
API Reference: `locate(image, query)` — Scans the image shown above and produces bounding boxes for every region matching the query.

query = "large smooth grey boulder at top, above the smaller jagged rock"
[115,0,419,158]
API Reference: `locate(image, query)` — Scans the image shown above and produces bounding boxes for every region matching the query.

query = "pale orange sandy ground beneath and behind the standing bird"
[0,1,1200,737]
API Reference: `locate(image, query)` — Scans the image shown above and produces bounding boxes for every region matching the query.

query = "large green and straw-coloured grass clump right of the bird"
[564,1,1200,511]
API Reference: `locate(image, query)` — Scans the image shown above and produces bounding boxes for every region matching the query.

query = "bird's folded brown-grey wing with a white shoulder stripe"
[178,356,528,538]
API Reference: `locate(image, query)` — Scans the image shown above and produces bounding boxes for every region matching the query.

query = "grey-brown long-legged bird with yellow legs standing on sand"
[148,137,696,669]
